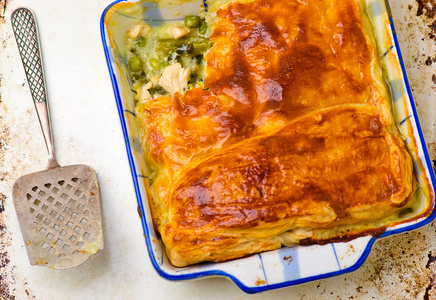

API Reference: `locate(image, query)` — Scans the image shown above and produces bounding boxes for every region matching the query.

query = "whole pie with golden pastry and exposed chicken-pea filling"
[121,0,428,267]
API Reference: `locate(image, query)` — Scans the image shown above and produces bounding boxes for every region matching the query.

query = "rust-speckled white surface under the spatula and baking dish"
[0,0,436,299]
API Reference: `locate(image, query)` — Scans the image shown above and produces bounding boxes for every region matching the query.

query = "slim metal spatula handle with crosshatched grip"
[11,8,58,168]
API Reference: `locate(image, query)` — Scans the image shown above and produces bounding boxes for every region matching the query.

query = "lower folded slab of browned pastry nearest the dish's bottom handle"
[158,105,412,264]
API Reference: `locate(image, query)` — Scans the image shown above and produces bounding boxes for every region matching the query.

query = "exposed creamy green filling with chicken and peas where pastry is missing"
[125,16,212,101]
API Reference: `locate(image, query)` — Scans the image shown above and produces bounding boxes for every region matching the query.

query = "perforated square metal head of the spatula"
[12,165,104,269]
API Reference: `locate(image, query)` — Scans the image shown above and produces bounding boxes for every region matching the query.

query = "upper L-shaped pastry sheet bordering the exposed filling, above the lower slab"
[139,0,390,176]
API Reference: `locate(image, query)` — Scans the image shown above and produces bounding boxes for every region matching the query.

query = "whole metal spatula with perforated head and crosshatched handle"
[12,8,103,269]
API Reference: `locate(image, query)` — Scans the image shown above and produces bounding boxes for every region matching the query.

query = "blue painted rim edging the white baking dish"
[100,0,436,294]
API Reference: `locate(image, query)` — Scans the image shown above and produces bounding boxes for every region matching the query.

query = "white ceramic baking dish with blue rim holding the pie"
[101,1,435,293]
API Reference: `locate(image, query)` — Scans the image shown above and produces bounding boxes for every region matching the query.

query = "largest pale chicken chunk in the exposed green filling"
[159,63,191,94]
